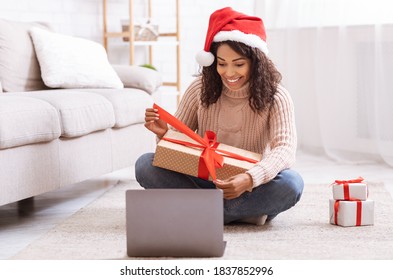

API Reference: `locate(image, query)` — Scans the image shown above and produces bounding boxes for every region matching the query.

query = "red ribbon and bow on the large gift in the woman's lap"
[153,104,258,180]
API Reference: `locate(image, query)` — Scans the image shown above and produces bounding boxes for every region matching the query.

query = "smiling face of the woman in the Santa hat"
[217,44,251,90]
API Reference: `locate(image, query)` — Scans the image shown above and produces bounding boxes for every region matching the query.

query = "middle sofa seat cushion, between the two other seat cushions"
[14,89,115,138]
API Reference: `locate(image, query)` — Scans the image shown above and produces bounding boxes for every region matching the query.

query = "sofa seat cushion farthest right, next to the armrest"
[80,88,153,127]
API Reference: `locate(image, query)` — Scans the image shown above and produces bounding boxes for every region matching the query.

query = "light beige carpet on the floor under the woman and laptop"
[9,181,393,260]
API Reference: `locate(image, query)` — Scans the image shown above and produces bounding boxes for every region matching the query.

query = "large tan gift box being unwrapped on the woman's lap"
[153,130,262,180]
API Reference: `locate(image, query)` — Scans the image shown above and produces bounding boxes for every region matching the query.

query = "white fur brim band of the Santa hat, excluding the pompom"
[213,30,269,55]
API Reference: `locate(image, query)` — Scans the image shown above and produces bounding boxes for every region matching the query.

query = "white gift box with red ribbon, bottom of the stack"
[329,199,374,227]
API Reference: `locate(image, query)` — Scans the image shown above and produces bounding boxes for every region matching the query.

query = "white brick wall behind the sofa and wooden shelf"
[0,0,255,98]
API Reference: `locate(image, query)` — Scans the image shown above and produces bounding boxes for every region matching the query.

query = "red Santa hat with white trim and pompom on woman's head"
[196,7,268,66]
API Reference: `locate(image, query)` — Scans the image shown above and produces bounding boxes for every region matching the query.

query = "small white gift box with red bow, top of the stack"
[332,178,368,200]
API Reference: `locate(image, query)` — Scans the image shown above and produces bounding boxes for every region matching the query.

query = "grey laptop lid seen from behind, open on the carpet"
[126,189,226,257]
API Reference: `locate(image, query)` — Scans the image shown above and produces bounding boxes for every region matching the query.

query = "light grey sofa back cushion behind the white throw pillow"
[0,19,46,91]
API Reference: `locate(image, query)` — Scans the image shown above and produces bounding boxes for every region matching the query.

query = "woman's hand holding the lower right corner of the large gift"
[213,173,253,199]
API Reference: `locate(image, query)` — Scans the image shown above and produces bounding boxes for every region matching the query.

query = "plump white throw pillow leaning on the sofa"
[30,27,123,89]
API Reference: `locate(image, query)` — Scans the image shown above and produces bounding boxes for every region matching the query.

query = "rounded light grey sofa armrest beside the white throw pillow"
[112,64,162,94]
